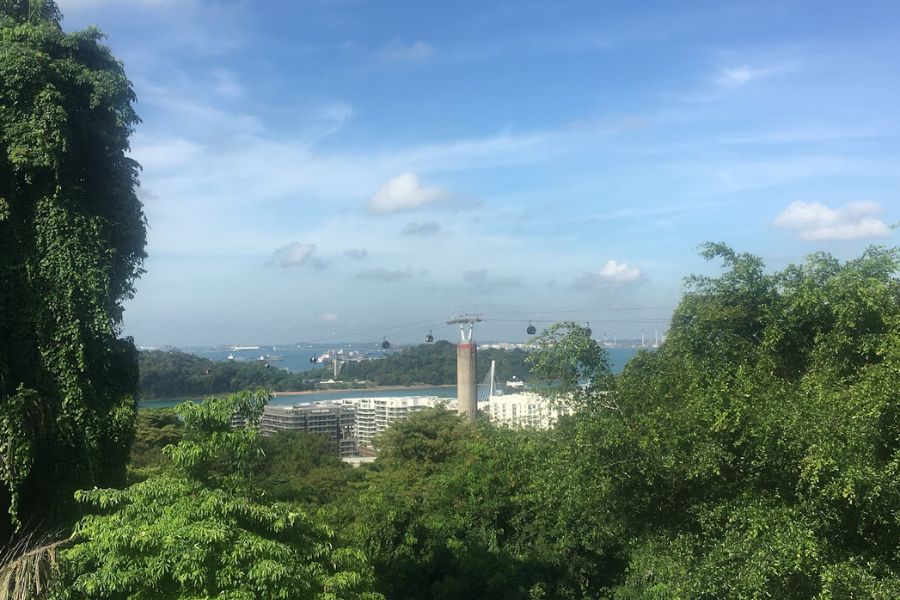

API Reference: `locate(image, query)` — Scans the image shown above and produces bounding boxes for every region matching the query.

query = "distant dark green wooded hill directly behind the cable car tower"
[341,340,528,385]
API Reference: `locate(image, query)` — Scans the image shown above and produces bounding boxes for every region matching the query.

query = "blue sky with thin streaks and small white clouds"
[58,0,900,347]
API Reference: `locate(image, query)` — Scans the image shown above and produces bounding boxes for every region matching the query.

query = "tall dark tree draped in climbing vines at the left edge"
[0,0,145,534]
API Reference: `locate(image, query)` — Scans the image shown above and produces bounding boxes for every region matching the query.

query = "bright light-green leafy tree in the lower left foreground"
[57,392,380,600]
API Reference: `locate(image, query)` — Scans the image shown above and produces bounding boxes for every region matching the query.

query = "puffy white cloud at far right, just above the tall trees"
[774,201,889,242]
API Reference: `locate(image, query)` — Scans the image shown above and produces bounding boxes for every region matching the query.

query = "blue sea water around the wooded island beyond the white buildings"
[140,346,638,408]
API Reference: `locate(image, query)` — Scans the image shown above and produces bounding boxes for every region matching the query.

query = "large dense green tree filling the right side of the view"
[534,244,900,599]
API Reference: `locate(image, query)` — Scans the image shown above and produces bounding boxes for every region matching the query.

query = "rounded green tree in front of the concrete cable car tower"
[335,407,552,600]
